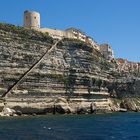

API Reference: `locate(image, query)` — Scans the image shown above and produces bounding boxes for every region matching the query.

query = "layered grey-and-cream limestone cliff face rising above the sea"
[0,24,140,114]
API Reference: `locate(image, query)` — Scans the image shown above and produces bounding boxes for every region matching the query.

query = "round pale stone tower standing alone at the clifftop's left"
[24,11,40,30]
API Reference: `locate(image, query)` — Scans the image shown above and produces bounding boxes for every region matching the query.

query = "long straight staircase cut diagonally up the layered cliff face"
[2,39,62,98]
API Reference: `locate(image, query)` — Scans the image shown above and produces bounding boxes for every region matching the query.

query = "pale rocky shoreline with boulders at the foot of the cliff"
[0,97,140,117]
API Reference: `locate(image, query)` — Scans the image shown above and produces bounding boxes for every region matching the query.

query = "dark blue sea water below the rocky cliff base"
[0,113,140,140]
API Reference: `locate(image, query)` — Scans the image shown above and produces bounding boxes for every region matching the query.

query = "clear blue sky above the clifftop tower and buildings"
[0,0,140,62]
